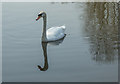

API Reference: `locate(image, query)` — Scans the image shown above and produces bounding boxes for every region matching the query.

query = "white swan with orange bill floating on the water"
[36,11,65,42]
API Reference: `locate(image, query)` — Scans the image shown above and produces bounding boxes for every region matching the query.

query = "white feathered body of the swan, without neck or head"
[46,26,65,41]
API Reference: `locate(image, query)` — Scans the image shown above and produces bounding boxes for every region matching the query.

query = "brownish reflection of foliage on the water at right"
[86,2,118,62]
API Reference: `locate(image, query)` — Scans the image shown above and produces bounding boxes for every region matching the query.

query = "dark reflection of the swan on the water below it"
[38,38,64,71]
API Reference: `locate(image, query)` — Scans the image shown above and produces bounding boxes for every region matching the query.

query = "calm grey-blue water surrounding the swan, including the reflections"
[2,3,118,82]
